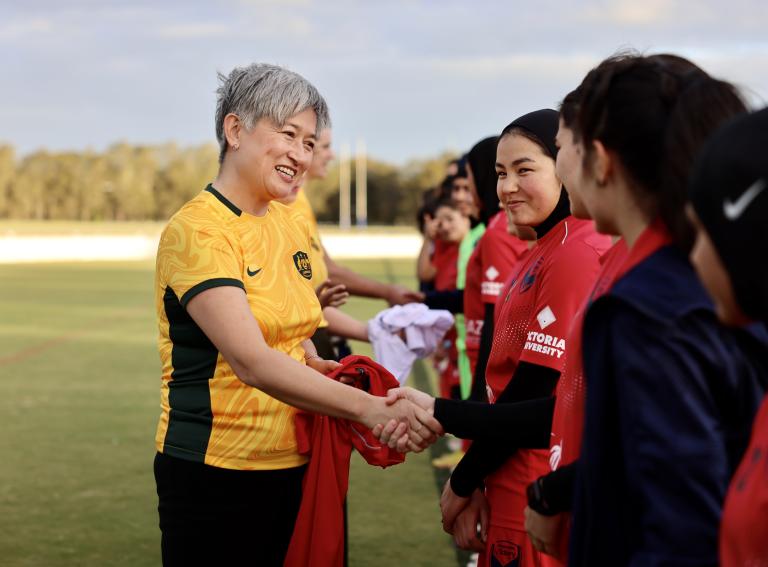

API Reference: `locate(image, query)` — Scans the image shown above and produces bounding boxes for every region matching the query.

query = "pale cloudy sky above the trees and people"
[0,0,768,162]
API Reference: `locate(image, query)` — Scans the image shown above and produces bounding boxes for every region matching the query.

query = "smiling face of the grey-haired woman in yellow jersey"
[234,108,317,200]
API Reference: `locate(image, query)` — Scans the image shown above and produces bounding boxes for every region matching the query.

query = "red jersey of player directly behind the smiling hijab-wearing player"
[464,211,528,375]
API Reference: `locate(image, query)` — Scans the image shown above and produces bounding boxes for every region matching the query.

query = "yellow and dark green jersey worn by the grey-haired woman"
[155,185,321,470]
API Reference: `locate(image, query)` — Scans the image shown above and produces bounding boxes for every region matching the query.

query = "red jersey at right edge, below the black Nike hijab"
[720,397,768,567]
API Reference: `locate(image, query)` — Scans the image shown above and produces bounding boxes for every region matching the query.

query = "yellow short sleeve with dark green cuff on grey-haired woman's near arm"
[157,218,245,308]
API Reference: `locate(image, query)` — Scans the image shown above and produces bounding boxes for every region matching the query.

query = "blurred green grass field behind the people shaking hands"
[0,261,457,567]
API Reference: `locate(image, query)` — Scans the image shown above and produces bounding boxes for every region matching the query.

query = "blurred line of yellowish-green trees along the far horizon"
[0,143,453,225]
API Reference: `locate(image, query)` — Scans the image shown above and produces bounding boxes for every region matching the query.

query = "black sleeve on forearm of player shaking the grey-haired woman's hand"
[435,397,555,449]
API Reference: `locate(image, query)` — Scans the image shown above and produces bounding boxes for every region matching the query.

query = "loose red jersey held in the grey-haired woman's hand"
[284,356,405,567]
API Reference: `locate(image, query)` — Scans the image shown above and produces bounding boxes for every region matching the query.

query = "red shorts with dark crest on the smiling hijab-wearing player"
[477,524,563,567]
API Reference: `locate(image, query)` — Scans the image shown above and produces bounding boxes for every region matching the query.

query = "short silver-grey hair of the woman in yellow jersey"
[216,63,331,163]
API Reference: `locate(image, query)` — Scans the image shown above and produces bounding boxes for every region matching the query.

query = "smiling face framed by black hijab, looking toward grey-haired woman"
[496,133,560,227]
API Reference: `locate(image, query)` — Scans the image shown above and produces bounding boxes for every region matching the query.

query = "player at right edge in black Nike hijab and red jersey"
[689,109,768,567]
